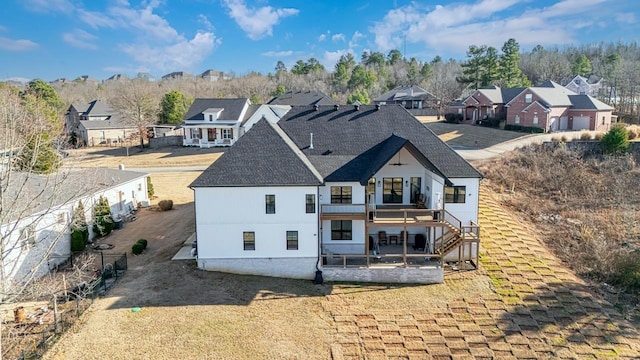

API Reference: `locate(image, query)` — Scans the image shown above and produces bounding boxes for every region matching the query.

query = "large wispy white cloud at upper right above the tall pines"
[370,0,606,52]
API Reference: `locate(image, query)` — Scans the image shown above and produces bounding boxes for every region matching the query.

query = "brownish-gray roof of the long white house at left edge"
[2,168,147,221]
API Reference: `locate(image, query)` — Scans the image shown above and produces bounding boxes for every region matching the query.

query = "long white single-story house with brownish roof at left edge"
[0,168,149,292]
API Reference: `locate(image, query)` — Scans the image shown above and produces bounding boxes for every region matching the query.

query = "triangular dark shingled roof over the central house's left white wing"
[190,119,322,187]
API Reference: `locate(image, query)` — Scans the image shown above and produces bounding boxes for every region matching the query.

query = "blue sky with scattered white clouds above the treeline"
[0,0,640,80]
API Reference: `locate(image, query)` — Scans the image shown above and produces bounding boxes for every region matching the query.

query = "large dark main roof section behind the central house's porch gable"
[278,105,482,181]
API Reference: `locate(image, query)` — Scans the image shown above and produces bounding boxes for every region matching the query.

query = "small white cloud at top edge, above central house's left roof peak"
[223,0,298,40]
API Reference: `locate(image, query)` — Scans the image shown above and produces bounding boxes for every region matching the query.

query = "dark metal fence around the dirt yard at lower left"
[0,252,127,360]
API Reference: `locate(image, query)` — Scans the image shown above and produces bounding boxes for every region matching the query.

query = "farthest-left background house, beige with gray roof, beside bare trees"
[65,100,139,146]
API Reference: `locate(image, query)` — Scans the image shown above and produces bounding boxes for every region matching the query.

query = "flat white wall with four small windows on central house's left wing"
[194,187,318,260]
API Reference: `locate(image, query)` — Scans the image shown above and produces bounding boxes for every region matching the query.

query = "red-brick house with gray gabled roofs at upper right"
[452,81,613,132]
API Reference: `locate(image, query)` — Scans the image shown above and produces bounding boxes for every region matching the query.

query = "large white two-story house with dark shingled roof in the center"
[190,105,482,283]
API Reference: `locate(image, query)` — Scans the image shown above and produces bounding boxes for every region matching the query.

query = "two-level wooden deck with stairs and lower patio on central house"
[320,204,480,283]
